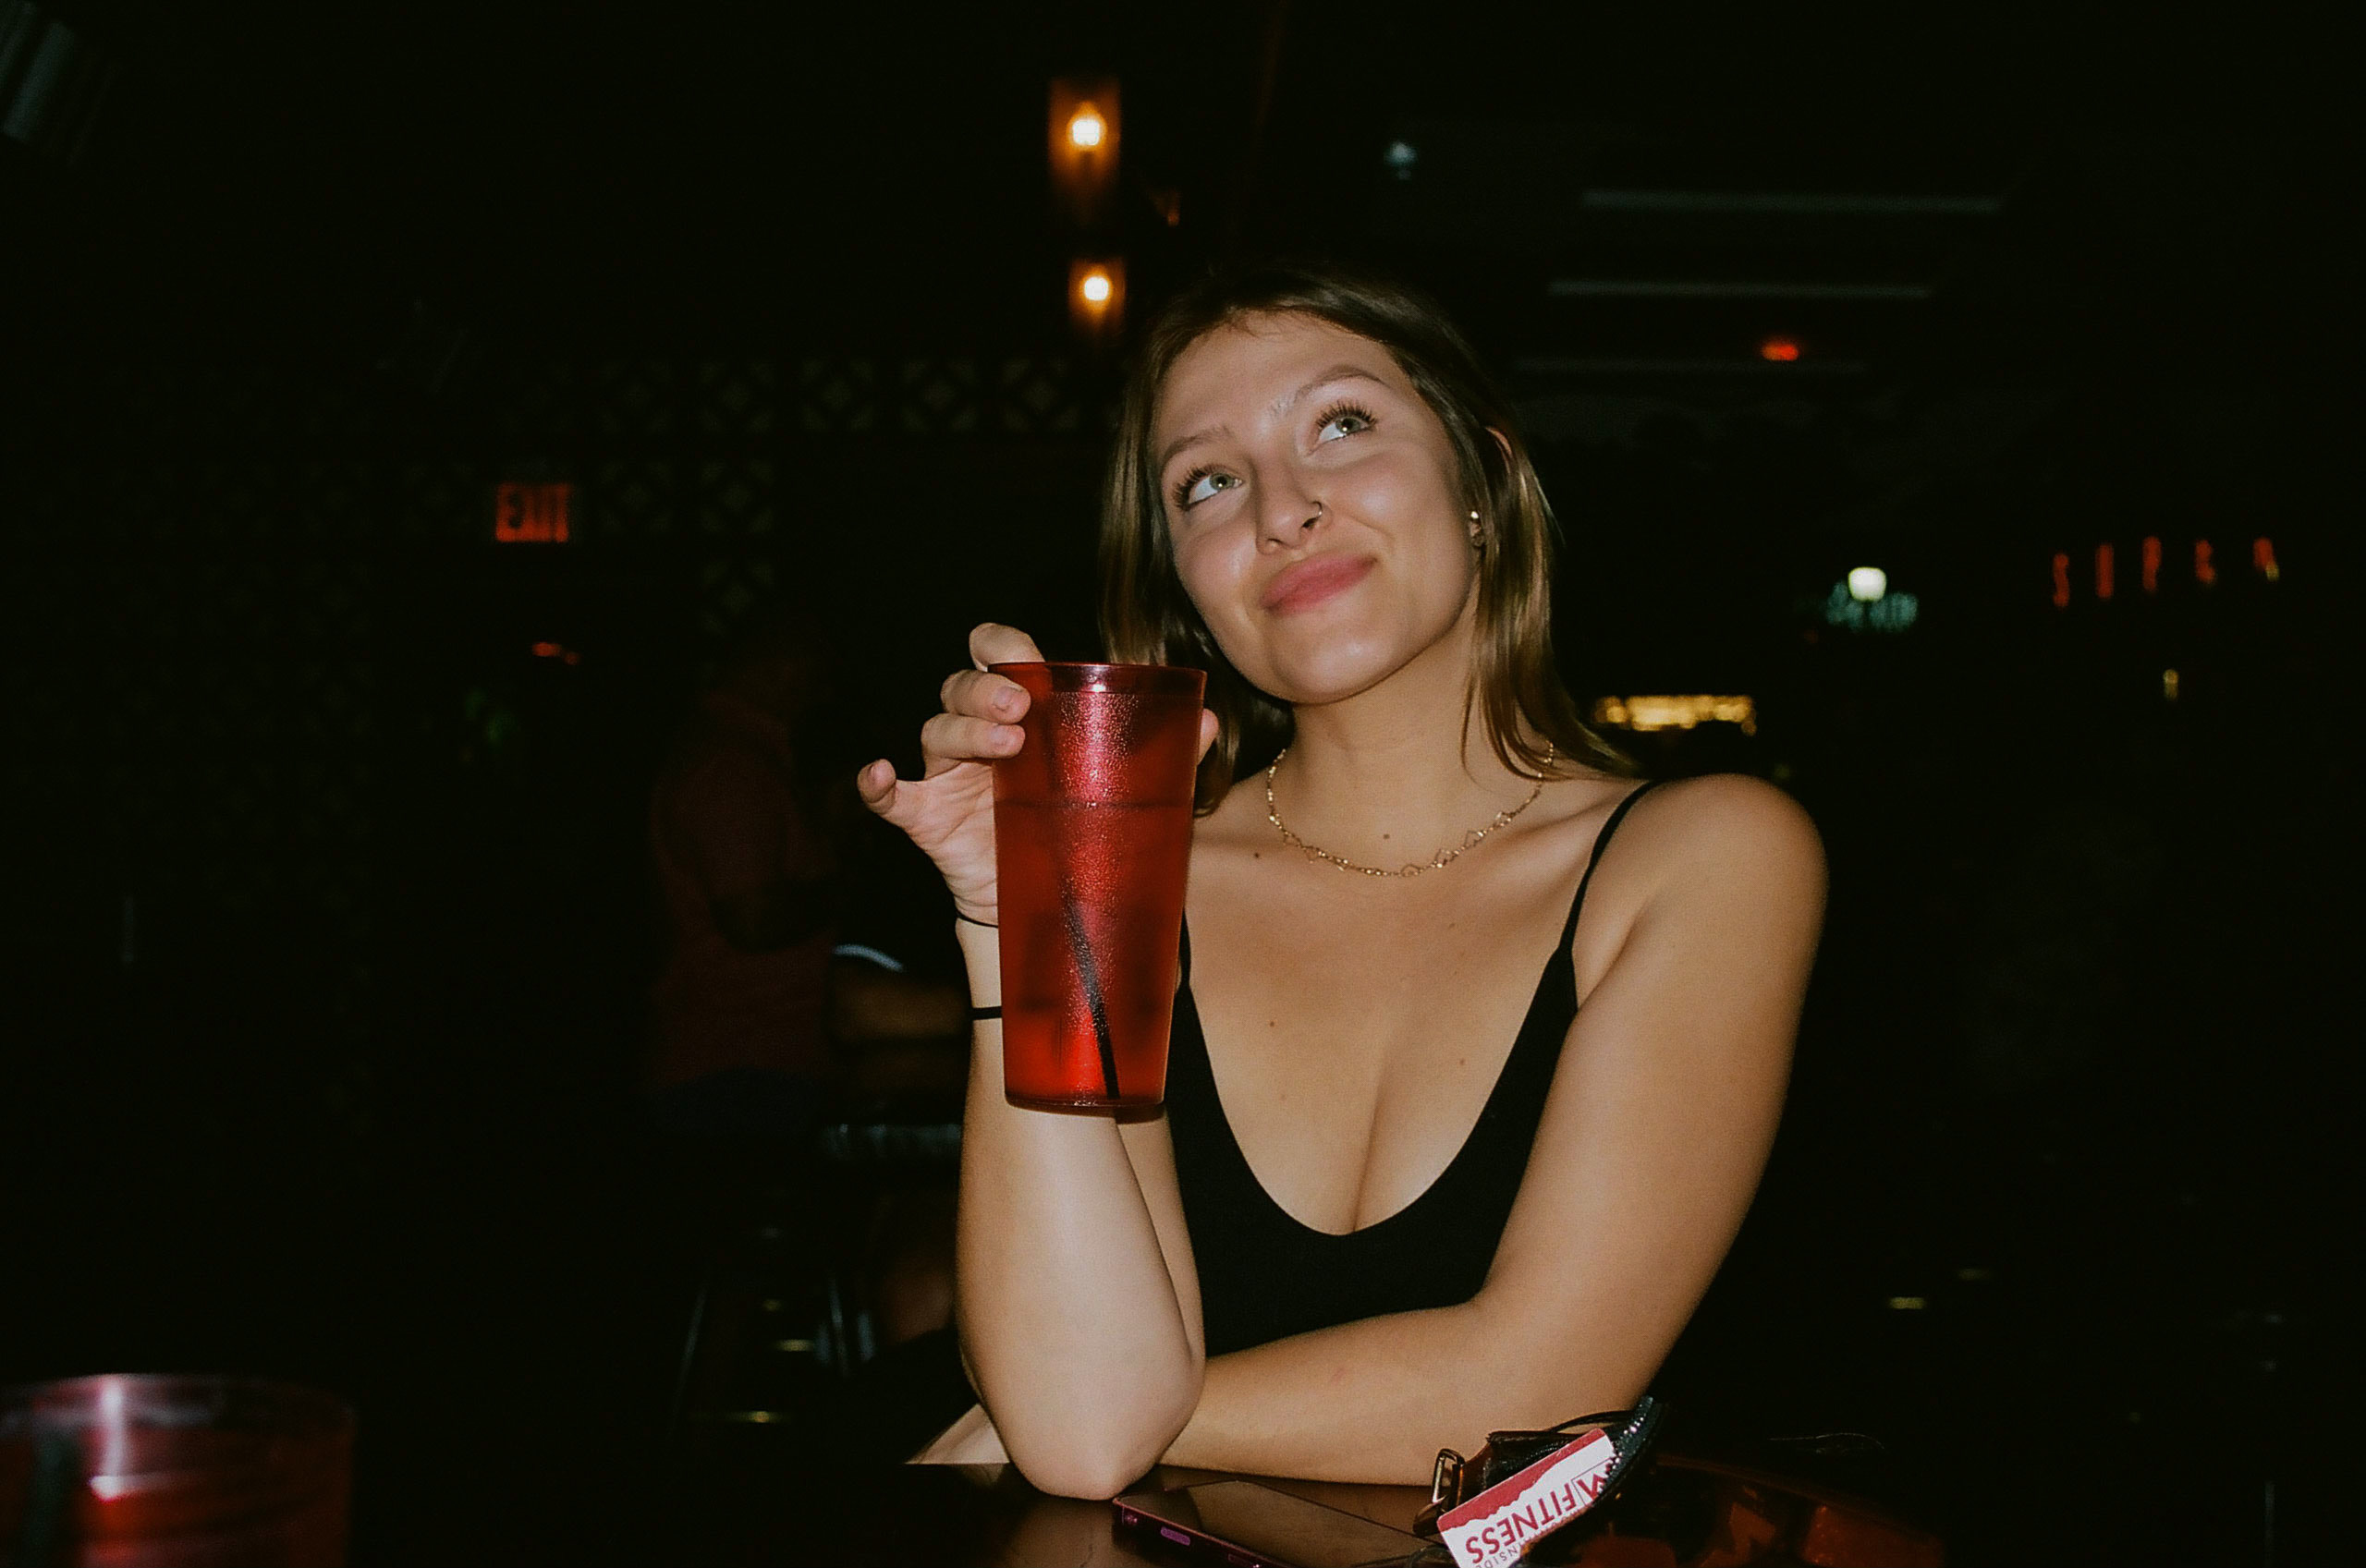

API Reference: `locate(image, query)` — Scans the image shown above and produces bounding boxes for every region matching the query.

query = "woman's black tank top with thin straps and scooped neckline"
[1166,783,1652,1355]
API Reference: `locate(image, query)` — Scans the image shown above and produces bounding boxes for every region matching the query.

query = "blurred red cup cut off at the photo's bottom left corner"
[0,1374,352,1568]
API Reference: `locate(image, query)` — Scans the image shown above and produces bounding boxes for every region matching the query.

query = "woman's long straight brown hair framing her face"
[1100,262,1635,813]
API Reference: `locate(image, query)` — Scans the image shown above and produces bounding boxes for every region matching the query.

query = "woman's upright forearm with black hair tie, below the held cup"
[956,922,1200,1497]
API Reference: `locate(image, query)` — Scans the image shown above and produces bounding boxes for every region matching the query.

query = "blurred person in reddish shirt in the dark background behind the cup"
[648,610,968,1345]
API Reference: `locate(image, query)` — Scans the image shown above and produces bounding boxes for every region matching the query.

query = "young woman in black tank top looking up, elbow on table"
[859,267,1824,1497]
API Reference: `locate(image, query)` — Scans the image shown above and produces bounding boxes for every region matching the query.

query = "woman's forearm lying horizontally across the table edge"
[1165,1301,1635,1485]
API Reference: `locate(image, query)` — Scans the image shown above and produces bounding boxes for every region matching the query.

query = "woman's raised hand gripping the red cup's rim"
[854,622,1043,925]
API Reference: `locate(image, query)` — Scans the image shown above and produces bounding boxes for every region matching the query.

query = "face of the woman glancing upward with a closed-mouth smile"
[1153,314,1479,702]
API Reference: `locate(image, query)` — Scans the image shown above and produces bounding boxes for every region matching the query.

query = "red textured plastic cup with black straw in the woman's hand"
[994,664,1207,1107]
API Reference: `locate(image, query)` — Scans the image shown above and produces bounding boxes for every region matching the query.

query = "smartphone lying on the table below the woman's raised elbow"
[1110,1480,1453,1568]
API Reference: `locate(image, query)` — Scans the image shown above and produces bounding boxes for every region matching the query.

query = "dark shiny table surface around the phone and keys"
[677,1454,1943,1568]
